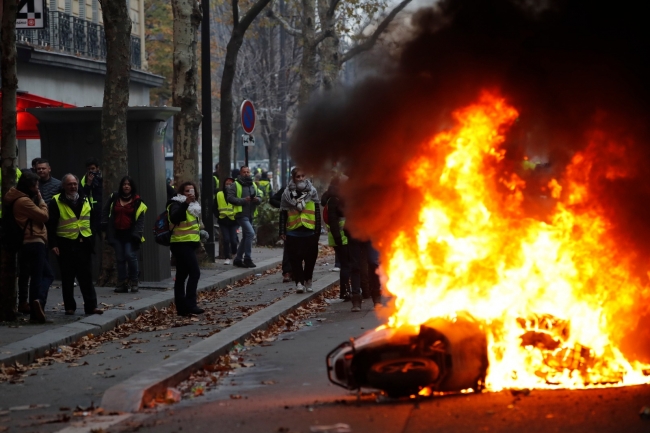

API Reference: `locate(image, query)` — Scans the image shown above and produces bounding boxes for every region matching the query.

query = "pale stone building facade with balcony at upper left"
[16,0,163,167]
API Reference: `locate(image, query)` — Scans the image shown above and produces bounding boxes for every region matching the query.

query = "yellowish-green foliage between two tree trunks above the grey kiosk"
[144,0,174,106]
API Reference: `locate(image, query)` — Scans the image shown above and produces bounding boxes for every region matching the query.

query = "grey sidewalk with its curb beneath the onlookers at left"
[0,247,282,365]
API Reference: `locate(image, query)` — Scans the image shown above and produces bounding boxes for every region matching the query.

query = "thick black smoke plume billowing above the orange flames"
[291,0,650,362]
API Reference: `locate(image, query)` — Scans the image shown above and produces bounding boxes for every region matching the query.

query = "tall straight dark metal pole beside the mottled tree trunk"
[201,0,215,262]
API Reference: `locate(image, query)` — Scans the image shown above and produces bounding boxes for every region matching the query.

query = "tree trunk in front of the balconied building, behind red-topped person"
[97,0,131,286]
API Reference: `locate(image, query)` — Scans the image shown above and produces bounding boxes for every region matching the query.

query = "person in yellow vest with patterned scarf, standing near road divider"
[280,167,321,293]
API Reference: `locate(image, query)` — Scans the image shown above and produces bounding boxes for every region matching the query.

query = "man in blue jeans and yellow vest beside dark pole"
[226,166,262,268]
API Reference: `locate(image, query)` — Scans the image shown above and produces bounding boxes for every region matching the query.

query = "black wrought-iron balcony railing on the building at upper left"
[16,11,142,69]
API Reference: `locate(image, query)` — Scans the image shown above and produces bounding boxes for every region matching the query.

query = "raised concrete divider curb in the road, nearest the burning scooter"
[101,273,339,412]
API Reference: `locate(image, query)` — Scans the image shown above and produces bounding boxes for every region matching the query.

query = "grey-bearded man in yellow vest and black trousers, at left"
[47,173,103,316]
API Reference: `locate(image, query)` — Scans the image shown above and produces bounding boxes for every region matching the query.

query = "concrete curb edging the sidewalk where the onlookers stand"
[0,257,282,365]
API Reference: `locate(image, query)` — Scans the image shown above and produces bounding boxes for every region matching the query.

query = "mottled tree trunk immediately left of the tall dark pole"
[172,0,201,185]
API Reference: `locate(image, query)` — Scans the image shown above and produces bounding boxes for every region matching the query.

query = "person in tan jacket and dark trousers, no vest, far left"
[4,172,54,323]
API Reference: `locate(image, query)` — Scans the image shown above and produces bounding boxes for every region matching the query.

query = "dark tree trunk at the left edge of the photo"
[0,0,18,321]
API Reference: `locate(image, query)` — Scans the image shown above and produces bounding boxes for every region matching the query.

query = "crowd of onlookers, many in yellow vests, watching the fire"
[0,158,381,323]
